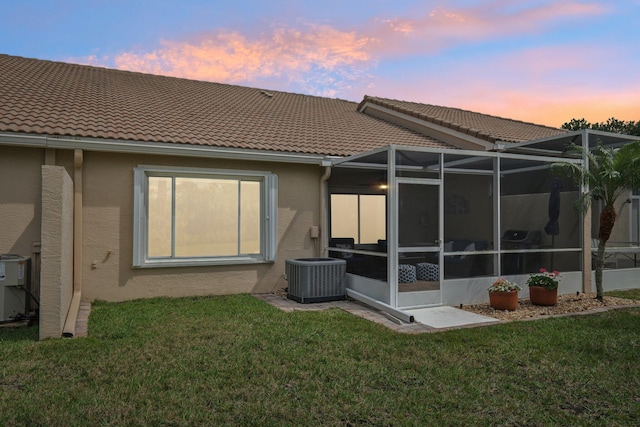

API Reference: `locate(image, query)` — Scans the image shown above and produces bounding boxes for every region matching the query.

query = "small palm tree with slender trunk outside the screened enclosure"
[552,141,640,301]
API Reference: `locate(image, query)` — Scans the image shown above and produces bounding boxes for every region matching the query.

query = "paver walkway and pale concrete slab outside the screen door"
[254,294,500,334]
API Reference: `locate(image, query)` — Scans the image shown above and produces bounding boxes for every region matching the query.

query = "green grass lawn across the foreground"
[0,295,640,426]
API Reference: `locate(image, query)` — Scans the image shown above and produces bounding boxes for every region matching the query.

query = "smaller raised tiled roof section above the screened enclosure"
[360,96,567,142]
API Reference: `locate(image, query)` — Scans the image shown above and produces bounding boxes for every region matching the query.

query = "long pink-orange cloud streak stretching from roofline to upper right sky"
[75,0,603,94]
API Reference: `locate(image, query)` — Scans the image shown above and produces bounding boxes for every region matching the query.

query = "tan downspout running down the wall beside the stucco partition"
[62,149,83,337]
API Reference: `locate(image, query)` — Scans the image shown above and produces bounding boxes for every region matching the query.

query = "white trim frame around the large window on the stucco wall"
[133,165,278,268]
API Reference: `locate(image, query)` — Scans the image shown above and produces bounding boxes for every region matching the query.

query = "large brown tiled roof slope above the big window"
[0,55,450,156]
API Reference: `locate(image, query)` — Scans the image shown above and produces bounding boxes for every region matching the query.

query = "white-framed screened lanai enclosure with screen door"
[327,132,637,320]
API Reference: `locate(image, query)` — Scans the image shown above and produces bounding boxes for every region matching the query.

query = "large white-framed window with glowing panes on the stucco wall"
[133,167,277,267]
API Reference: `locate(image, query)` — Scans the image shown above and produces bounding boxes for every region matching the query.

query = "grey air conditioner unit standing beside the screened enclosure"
[285,258,347,304]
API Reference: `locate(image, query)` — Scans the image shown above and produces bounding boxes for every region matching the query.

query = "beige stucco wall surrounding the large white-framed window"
[82,152,321,301]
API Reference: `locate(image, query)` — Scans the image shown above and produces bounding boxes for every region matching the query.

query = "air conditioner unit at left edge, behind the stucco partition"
[0,254,31,321]
